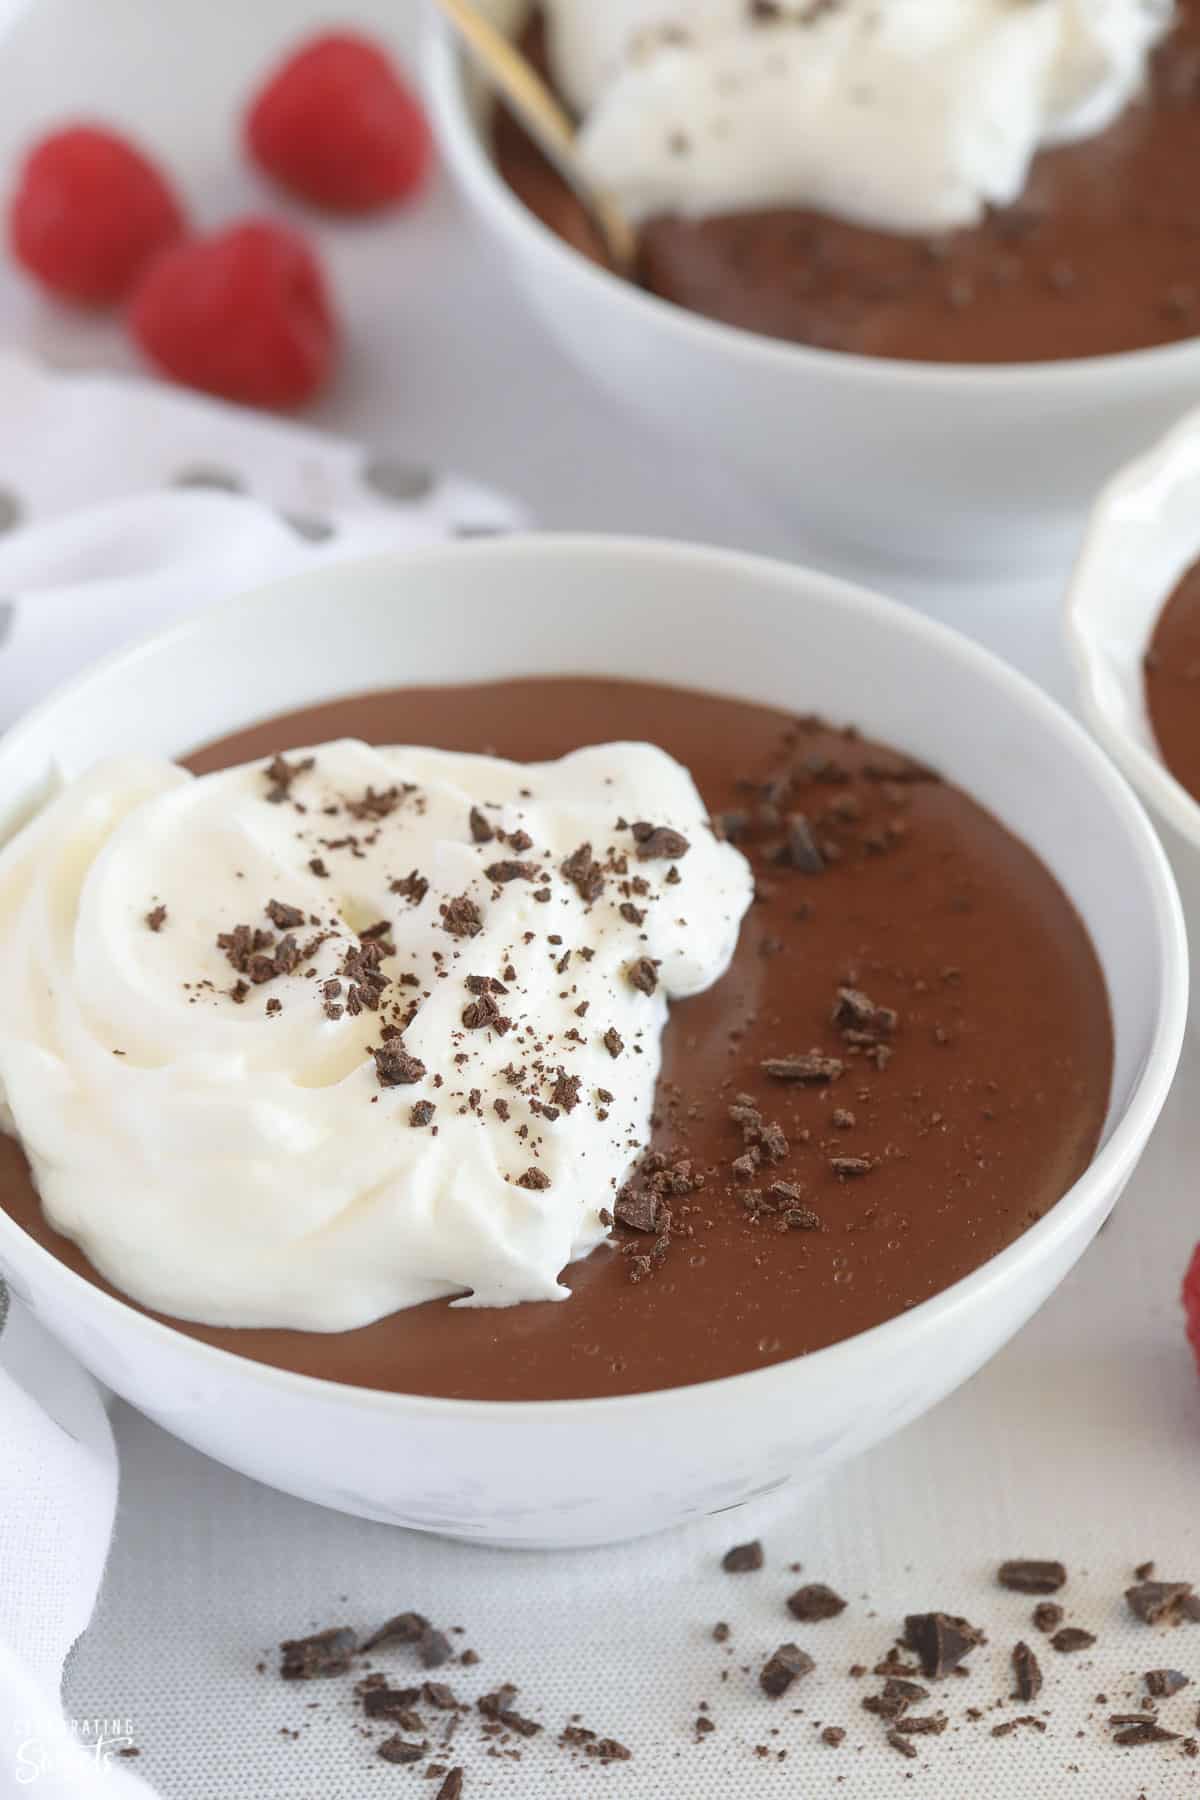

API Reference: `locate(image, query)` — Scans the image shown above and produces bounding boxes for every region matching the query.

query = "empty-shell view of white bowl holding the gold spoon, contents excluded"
[425,0,1200,569]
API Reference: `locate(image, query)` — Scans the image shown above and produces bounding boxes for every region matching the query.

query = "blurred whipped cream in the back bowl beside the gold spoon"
[545,0,1175,232]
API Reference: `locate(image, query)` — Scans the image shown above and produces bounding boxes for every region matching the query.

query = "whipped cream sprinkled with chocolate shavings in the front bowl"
[0,740,752,1330]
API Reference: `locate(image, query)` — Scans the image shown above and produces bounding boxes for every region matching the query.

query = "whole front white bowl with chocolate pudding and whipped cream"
[0,538,1187,1544]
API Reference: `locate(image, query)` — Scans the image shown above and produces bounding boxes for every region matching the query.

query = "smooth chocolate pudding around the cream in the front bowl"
[0,677,1112,1400]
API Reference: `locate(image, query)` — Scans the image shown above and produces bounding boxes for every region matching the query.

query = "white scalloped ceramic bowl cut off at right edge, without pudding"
[1065,410,1200,1022]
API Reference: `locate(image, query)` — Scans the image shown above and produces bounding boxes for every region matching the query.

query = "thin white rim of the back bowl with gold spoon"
[421,0,1200,401]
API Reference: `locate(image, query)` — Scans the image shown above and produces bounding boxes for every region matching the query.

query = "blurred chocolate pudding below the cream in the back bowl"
[495,0,1200,364]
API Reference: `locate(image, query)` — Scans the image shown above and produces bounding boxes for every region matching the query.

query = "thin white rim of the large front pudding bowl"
[0,533,1187,1422]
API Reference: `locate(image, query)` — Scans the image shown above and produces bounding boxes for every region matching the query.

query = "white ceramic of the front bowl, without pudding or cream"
[0,538,1187,1544]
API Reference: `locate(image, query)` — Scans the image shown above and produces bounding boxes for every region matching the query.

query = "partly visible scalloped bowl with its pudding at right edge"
[1065,401,1200,1015]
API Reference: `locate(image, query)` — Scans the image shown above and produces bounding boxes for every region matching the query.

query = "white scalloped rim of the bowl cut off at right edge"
[1063,407,1200,850]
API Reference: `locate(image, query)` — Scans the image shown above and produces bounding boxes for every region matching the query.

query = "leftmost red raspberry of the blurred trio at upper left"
[9,124,184,306]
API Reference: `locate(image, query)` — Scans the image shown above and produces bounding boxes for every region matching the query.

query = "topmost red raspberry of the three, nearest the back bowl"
[246,32,430,212]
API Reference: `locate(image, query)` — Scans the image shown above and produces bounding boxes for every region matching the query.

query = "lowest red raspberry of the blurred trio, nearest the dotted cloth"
[130,218,336,407]
